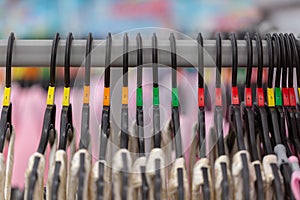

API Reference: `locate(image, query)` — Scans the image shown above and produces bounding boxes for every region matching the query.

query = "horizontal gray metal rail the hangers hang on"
[0,39,268,67]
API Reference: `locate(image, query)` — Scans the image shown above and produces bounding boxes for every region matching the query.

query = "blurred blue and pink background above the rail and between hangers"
[0,0,300,188]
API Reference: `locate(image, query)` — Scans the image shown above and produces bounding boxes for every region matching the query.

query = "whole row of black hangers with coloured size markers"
[0,33,300,199]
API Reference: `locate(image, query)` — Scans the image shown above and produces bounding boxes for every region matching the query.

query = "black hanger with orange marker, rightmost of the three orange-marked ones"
[120,33,128,149]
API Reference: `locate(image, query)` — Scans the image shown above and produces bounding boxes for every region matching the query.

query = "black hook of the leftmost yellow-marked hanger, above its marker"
[6,32,15,87]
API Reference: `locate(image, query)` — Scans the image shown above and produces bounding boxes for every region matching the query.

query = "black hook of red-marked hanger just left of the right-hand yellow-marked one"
[254,33,263,88]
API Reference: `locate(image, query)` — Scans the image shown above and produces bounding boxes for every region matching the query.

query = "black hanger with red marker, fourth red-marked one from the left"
[242,33,264,200]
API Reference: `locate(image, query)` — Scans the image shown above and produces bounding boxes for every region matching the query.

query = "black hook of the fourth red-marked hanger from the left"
[245,32,253,88]
